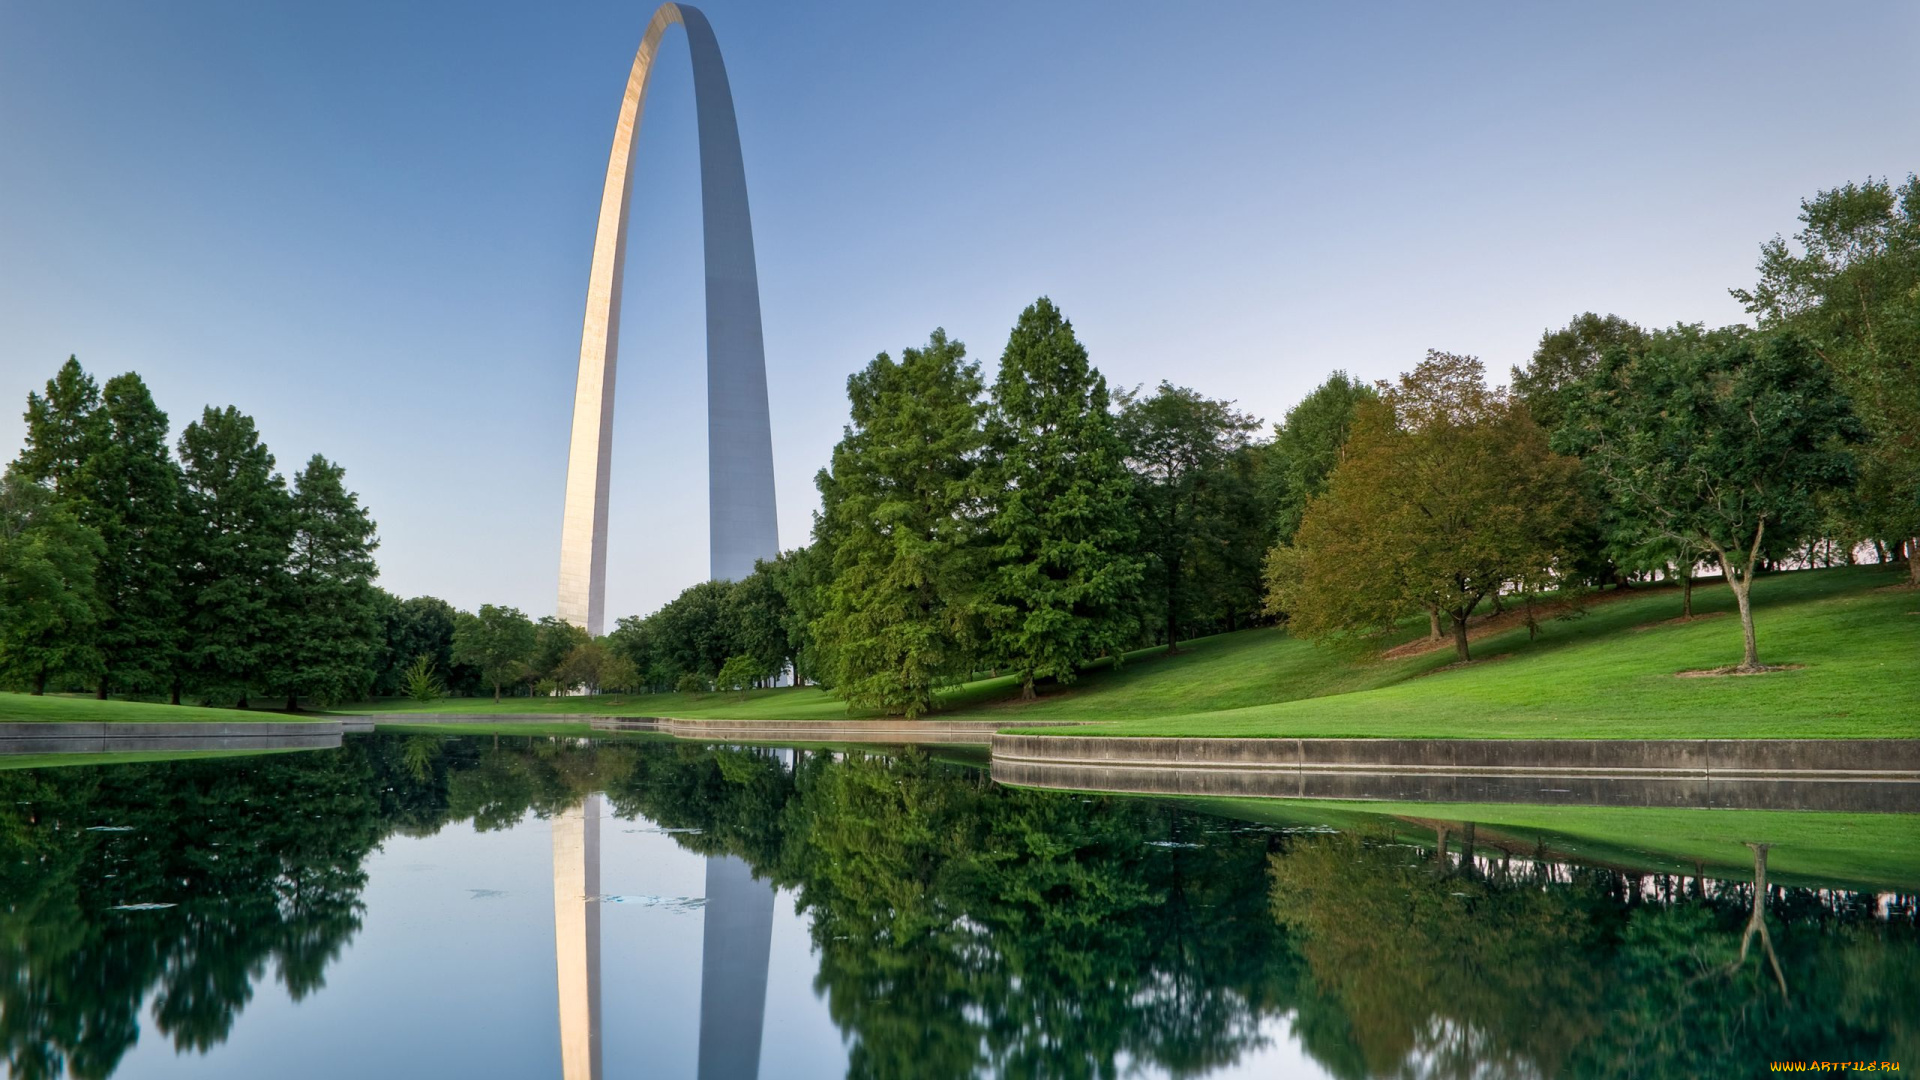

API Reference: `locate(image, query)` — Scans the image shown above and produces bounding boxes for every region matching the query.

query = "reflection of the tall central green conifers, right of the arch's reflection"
[611,748,1290,1076]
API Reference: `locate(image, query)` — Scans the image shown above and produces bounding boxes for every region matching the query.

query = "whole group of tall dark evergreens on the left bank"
[0,359,380,707]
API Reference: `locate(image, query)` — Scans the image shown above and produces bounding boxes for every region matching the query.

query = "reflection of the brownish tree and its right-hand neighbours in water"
[1271,822,1920,1076]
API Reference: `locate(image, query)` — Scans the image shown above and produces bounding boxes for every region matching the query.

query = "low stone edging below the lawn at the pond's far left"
[0,719,349,755]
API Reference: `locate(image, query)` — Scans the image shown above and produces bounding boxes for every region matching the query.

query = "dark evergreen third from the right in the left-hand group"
[73,371,182,698]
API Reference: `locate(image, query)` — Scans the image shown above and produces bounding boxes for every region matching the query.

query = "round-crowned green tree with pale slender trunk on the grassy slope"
[1565,325,1860,671]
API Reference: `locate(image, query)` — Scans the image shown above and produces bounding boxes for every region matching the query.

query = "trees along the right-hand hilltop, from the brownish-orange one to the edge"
[1267,179,1920,671]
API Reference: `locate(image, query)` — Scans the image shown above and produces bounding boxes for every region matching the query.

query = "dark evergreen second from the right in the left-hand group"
[175,405,294,707]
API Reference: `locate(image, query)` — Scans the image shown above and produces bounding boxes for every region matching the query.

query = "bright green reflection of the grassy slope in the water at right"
[1181,799,1920,890]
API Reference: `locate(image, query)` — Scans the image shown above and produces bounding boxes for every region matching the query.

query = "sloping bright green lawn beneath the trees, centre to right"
[337,567,1920,738]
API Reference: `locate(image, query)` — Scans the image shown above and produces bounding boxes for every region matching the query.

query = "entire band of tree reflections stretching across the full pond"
[0,736,1920,1078]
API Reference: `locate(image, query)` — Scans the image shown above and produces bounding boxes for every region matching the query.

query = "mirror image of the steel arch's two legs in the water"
[553,792,774,1080]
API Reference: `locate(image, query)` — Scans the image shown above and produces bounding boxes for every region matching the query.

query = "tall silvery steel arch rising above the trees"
[559,4,780,636]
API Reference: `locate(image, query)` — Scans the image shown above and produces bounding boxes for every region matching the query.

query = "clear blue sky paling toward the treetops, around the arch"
[0,0,1920,615]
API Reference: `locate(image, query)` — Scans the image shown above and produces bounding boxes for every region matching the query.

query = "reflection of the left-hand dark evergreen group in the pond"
[0,755,380,1078]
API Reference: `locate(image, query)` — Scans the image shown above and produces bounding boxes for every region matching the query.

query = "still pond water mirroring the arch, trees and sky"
[0,734,1920,1080]
